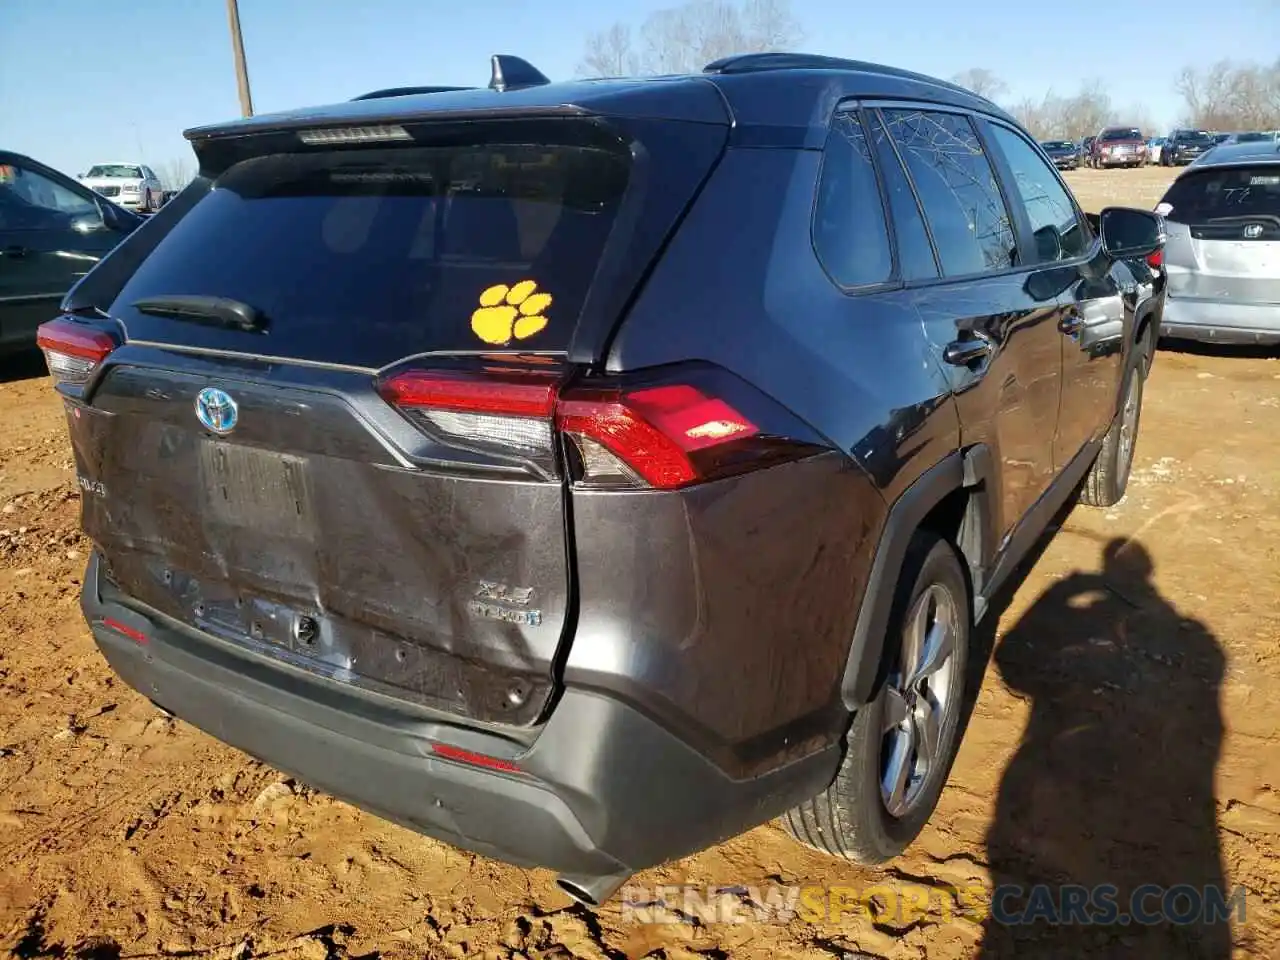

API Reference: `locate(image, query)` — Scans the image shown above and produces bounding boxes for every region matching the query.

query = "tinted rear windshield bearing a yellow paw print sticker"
[111,143,630,358]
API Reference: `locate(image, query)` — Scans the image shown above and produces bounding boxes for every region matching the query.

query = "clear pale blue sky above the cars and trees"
[0,0,1280,183]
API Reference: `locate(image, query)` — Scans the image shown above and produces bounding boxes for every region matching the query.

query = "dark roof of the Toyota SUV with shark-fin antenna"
[186,54,1011,146]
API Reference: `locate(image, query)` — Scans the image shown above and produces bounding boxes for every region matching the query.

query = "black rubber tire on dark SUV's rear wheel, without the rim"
[782,530,972,864]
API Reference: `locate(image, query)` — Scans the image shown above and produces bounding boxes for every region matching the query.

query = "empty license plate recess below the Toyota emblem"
[193,439,311,539]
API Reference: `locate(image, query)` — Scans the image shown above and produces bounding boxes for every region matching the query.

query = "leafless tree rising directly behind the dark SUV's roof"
[579,0,803,77]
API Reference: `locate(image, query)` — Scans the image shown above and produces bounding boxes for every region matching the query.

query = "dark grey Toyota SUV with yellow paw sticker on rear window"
[41,55,1164,904]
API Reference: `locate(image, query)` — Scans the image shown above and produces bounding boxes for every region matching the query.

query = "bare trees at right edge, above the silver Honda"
[1176,60,1280,131]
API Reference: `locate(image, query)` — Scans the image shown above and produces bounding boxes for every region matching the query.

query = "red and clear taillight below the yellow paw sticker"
[379,367,828,490]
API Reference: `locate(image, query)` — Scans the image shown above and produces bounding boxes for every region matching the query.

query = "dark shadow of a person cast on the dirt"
[979,539,1240,959]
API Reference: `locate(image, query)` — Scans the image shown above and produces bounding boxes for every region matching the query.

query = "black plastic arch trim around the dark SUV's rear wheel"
[840,444,996,710]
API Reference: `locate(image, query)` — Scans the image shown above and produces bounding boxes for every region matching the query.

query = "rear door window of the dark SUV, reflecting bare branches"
[884,110,1018,276]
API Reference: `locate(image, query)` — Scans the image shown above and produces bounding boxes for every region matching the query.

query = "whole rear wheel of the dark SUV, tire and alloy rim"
[783,530,970,864]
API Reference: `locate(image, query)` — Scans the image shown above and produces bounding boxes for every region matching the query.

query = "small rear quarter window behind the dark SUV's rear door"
[813,114,893,287]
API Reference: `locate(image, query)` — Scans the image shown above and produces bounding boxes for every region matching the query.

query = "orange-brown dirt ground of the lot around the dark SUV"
[0,169,1280,960]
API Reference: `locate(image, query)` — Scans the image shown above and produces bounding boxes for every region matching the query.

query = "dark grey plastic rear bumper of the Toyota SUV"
[82,556,838,877]
